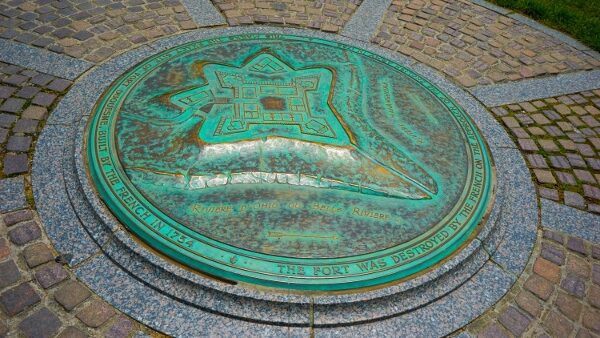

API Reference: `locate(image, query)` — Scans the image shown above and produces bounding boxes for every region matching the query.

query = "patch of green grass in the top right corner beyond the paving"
[491,0,600,51]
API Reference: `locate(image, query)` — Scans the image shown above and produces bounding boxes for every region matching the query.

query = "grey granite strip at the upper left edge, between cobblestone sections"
[0,39,92,80]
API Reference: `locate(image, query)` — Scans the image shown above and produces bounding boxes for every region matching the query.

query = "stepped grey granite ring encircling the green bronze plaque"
[32,27,539,336]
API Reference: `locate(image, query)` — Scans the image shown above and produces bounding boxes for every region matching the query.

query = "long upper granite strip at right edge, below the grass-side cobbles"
[469,70,600,107]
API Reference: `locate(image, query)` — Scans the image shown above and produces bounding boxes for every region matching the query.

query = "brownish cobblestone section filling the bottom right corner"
[467,231,600,338]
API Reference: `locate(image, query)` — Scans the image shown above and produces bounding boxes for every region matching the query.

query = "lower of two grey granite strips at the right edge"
[542,198,600,243]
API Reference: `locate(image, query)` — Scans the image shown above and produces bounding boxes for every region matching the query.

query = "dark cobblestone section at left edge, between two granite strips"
[0,62,71,177]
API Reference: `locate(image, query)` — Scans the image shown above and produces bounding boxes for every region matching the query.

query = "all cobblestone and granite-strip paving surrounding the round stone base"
[0,0,600,338]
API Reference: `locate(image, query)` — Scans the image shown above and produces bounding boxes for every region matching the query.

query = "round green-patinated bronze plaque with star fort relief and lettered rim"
[87,34,493,291]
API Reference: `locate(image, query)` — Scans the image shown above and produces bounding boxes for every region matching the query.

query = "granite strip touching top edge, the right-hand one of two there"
[341,0,392,41]
